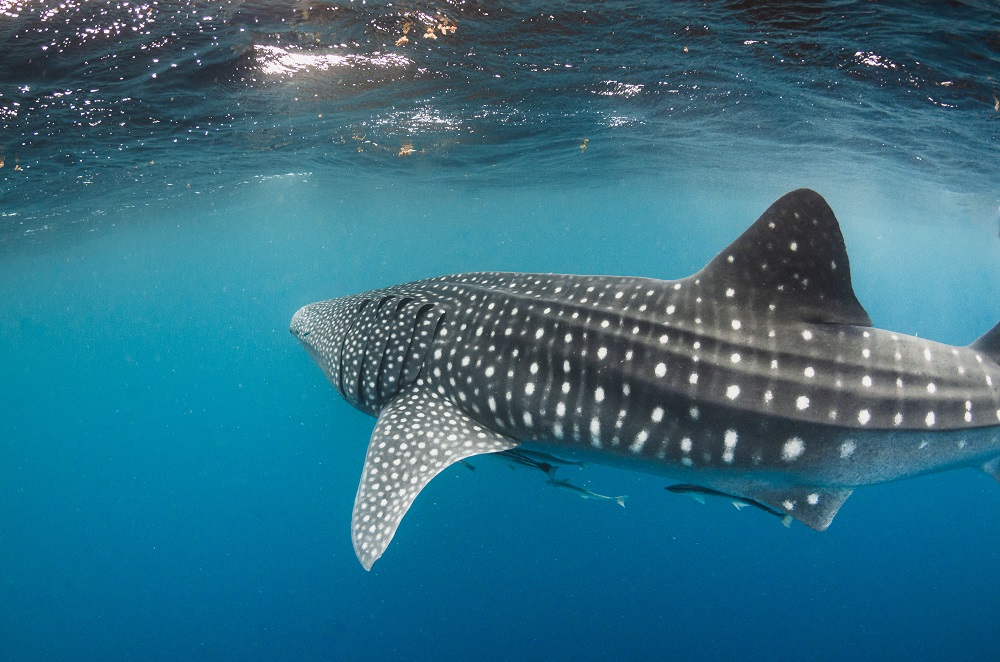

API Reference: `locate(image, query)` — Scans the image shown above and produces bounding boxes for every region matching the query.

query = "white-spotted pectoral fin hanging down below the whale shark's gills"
[351,386,518,570]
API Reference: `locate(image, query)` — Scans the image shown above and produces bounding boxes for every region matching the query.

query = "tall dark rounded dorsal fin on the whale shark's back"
[688,189,871,326]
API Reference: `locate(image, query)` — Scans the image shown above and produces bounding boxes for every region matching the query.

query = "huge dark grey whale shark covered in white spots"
[291,189,1000,569]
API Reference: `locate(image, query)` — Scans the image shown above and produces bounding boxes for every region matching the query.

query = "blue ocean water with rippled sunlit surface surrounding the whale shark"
[0,0,1000,660]
